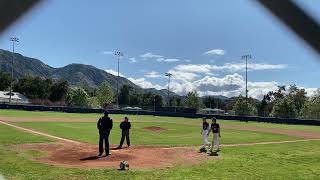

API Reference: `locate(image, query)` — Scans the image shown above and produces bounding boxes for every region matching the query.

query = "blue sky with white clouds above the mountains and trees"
[0,0,320,99]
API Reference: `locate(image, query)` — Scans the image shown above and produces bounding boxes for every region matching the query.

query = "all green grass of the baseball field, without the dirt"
[0,111,320,180]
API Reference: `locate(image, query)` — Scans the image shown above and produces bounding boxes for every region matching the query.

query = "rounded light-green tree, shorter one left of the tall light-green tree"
[66,88,89,107]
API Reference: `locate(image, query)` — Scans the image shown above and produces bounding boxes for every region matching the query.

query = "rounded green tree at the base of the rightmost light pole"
[233,96,257,116]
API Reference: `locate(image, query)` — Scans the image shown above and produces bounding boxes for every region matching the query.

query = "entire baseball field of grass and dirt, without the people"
[0,110,320,179]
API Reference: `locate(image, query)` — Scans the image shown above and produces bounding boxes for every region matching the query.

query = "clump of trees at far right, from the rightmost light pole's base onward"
[233,85,320,119]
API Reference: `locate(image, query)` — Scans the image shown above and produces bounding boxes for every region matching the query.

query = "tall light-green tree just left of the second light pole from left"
[97,81,114,107]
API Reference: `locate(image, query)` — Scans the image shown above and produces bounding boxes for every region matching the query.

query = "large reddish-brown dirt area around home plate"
[17,143,212,169]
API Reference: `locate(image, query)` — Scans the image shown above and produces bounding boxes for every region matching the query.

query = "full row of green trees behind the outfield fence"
[0,71,320,119]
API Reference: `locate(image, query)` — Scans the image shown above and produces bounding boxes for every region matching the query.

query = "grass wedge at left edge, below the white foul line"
[0,124,52,145]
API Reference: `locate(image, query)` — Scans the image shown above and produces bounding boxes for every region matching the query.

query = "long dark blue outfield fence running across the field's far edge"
[0,104,320,126]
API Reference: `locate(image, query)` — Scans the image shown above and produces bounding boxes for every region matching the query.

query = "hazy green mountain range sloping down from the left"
[0,49,177,97]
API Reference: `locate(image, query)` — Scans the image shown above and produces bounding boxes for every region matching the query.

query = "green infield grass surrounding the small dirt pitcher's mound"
[16,122,299,145]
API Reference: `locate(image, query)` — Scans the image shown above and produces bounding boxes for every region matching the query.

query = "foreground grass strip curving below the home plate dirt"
[0,141,320,179]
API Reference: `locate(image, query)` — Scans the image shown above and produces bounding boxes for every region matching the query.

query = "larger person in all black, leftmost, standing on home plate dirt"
[97,111,113,156]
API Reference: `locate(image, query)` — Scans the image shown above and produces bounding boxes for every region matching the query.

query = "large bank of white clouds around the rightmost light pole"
[159,63,287,99]
